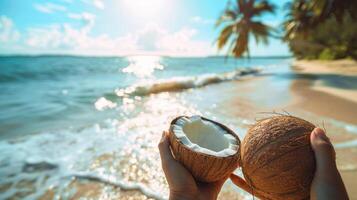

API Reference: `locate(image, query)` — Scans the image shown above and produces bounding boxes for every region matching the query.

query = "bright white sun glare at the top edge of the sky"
[122,0,169,17]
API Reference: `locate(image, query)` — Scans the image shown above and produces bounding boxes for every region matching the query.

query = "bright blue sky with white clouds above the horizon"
[0,0,290,56]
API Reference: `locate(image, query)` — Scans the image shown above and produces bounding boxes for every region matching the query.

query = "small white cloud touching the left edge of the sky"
[0,15,20,44]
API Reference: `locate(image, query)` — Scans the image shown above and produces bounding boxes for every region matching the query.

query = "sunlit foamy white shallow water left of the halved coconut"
[0,94,206,199]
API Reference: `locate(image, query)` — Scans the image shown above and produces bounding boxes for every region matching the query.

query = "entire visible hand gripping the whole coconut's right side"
[310,128,349,200]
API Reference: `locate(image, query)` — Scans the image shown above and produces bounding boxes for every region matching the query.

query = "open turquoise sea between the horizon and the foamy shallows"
[0,56,290,138]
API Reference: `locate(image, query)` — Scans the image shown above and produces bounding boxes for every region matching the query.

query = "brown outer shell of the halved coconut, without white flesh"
[169,116,240,182]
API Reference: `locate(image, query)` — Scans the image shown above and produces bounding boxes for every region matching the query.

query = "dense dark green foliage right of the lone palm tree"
[284,0,357,60]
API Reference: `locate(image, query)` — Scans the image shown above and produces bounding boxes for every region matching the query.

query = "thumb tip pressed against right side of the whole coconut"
[310,128,336,169]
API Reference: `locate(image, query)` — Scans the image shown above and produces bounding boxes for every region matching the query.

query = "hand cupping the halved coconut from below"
[158,132,228,200]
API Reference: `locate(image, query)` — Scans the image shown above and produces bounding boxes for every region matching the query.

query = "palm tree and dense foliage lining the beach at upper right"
[216,0,357,59]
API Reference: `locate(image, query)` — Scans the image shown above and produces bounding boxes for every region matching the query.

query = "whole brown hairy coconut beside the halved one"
[241,116,315,199]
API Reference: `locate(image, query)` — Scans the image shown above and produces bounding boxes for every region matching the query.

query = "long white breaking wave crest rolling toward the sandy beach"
[115,68,261,96]
